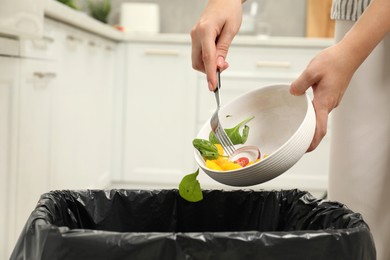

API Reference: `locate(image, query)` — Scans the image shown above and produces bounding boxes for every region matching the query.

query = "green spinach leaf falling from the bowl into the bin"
[179,169,203,202]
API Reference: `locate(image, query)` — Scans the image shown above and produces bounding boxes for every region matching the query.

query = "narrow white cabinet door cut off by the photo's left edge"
[0,57,19,259]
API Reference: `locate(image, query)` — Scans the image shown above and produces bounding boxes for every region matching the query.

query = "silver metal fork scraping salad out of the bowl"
[210,70,236,157]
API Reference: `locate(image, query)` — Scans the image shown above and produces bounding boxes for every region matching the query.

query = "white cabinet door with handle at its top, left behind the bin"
[12,60,56,250]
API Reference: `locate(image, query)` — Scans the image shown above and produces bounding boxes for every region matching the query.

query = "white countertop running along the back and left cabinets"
[45,0,333,48]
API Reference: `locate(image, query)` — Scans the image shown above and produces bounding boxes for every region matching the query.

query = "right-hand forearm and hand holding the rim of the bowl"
[290,0,390,152]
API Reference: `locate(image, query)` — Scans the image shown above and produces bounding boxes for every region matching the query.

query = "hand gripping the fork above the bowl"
[191,0,242,91]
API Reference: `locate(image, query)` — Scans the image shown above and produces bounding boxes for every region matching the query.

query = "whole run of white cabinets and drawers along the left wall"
[0,19,117,259]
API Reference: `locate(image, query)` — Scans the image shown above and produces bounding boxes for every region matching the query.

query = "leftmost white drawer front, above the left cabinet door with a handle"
[20,19,60,60]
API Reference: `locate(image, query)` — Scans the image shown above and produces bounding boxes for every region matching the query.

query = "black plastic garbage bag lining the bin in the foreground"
[11,190,376,260]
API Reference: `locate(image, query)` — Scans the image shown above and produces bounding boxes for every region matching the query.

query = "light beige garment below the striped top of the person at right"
[328,21,390,260]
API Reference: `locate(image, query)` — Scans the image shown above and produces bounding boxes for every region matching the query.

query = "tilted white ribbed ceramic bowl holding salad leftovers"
[195,84,316,186]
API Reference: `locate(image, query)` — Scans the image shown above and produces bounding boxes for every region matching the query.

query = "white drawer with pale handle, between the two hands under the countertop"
[227,45,320,75]
